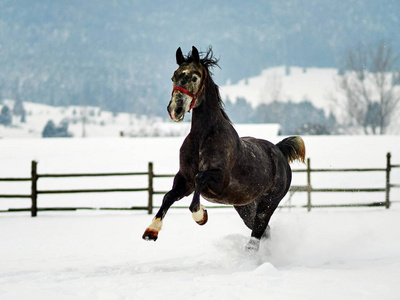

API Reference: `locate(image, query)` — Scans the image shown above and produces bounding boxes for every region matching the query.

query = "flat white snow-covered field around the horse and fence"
[0,135,400,299]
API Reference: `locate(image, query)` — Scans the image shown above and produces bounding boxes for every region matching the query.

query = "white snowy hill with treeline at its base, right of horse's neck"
[220,66,400,134]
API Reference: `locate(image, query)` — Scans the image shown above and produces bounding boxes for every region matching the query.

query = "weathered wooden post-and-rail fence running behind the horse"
[0,153,400,217]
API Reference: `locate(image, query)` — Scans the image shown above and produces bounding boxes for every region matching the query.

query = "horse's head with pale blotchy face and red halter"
[168,47,207,122]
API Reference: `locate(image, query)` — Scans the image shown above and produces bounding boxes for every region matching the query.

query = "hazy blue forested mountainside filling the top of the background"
[0,0,400,115]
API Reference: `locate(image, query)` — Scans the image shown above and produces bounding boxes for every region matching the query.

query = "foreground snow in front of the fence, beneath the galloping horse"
[0,207,400,299]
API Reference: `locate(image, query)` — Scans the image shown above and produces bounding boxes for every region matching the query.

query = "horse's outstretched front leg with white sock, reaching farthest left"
[142,173,192,241]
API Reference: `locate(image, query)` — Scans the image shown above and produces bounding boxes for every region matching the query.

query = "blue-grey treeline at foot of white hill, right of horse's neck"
[225,98,338,135]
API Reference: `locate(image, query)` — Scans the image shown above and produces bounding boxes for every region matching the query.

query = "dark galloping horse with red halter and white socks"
[142,46,305,251]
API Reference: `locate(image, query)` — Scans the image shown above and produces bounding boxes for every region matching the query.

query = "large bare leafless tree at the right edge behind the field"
[339,42,400,134]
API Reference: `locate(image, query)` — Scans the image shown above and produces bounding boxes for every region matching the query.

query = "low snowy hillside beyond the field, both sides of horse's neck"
[0,100,279,138]
